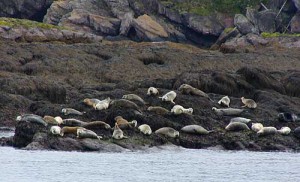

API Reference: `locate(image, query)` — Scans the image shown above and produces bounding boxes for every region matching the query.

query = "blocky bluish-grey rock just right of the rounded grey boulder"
[257,10,277,33]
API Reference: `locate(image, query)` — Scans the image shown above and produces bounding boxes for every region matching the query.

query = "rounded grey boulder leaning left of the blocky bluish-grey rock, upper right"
[234,14,255,35]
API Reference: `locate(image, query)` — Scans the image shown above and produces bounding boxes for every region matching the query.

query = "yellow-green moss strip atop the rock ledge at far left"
[0,18,66,29]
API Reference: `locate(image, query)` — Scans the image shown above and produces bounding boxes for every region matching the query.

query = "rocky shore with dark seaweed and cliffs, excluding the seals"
[0,0,300,152]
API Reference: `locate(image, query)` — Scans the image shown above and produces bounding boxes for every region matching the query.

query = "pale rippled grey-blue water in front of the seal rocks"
[0,133,300,182]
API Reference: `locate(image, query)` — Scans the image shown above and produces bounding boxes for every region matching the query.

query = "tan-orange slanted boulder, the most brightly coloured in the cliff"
[132,15,168,42]
